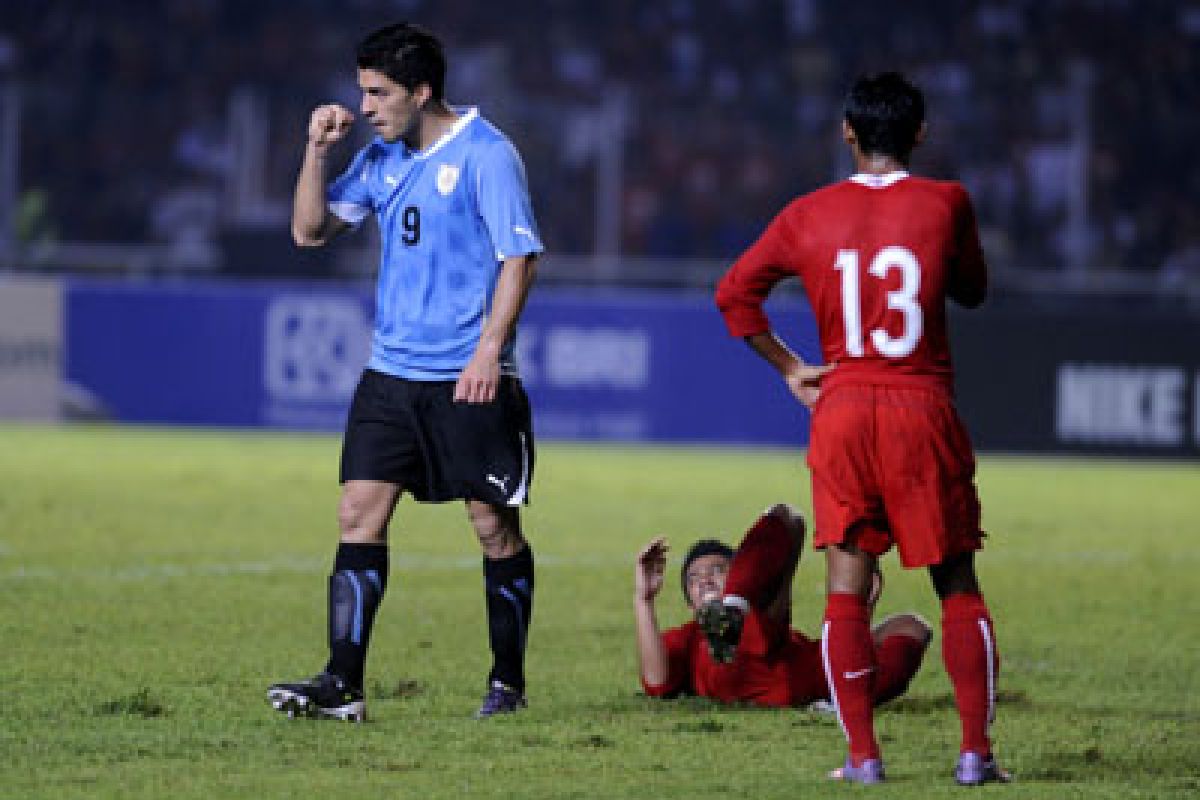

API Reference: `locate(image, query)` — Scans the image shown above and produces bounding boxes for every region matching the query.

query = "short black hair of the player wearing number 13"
[846,72,925,162]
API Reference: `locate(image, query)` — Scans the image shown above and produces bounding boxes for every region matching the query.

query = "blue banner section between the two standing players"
[520,291,818,445]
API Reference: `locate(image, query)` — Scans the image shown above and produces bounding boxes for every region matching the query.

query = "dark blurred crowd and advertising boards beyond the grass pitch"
[0,0,1200,457]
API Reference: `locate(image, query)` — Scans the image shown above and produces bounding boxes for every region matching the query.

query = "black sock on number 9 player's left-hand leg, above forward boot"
[325,542,388,688]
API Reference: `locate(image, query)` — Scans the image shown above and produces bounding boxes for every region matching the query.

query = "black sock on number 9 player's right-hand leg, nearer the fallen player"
[484,545,533,692]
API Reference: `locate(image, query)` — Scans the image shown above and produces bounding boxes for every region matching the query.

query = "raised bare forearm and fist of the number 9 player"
[292,104,354,247]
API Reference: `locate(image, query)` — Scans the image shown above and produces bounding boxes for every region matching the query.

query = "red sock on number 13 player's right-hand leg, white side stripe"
[942,594,1000,756]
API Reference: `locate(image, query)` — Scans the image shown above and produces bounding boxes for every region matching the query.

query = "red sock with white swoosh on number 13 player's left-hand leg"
[821,593,880,765]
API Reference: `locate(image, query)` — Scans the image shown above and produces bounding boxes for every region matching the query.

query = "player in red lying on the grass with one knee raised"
[634,504,930,706]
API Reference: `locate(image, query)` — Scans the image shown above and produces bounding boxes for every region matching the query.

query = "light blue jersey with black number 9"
[328,108,542,380]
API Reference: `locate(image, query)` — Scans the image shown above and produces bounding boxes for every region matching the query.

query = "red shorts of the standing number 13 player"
[808,384,983,567]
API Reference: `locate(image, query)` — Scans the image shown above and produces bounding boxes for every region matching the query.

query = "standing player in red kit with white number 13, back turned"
[702,72,1008,784]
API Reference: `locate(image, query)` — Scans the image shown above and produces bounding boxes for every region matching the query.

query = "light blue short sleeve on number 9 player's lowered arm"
[475,139,545,260]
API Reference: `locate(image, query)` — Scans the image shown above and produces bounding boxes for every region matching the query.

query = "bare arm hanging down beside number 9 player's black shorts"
[454,253,538,403]
